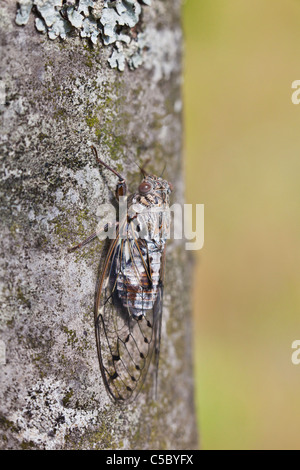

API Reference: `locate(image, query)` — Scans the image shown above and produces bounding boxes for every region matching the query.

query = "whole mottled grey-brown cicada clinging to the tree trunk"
[69,147,172,403]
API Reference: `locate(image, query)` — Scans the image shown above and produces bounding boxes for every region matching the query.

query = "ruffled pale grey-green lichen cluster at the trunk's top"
[15,0,151,71]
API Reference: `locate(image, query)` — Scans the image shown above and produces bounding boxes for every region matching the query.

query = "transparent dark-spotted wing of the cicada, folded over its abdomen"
[95,222,163,402]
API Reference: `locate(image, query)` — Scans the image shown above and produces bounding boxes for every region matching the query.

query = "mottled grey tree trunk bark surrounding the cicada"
[0,0,197,449]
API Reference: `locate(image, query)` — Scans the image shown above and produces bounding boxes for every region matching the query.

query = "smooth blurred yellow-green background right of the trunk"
[183,0,300,449]
